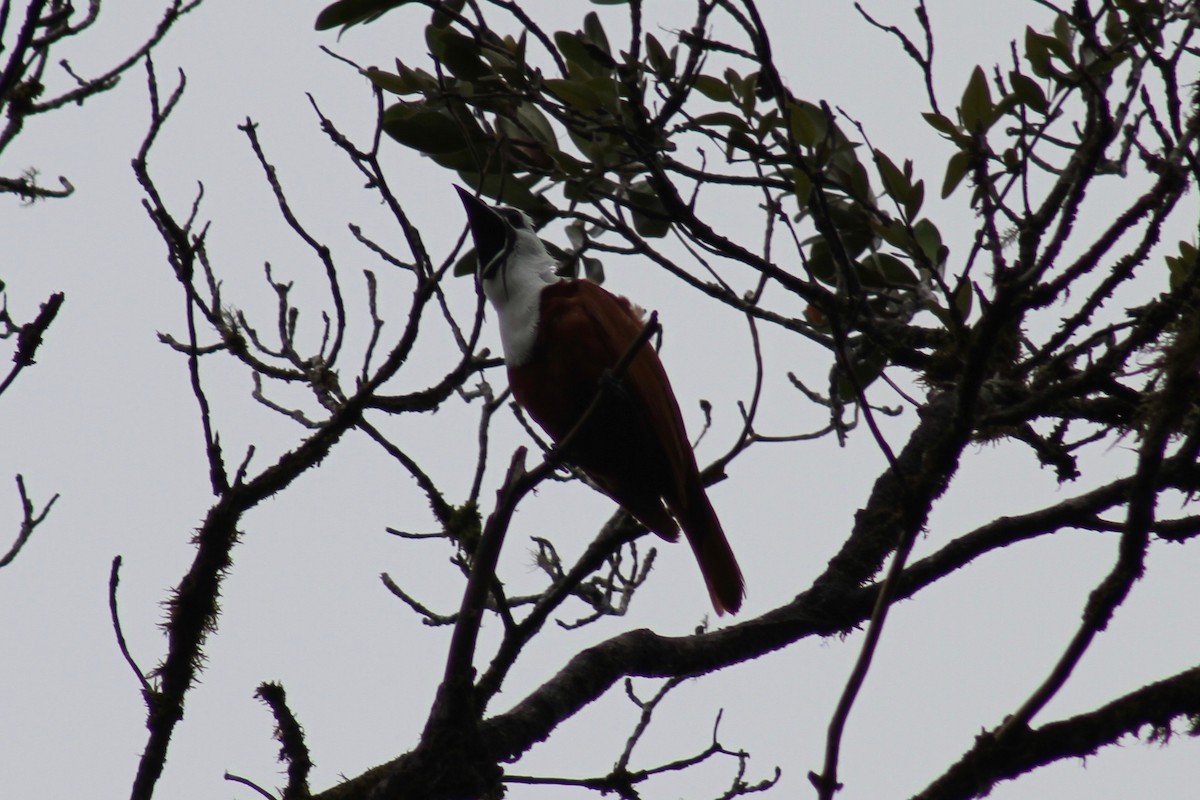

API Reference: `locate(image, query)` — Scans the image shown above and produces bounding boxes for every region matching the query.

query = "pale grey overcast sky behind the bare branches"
[0,0,1200,800]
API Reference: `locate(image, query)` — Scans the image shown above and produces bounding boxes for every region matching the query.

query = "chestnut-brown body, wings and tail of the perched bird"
[509,279,745,613]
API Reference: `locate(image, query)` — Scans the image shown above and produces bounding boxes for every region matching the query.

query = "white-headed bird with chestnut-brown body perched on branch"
[455,186,745,614]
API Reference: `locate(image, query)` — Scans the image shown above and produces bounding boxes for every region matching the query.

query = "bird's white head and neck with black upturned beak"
[455,187,559,366]
